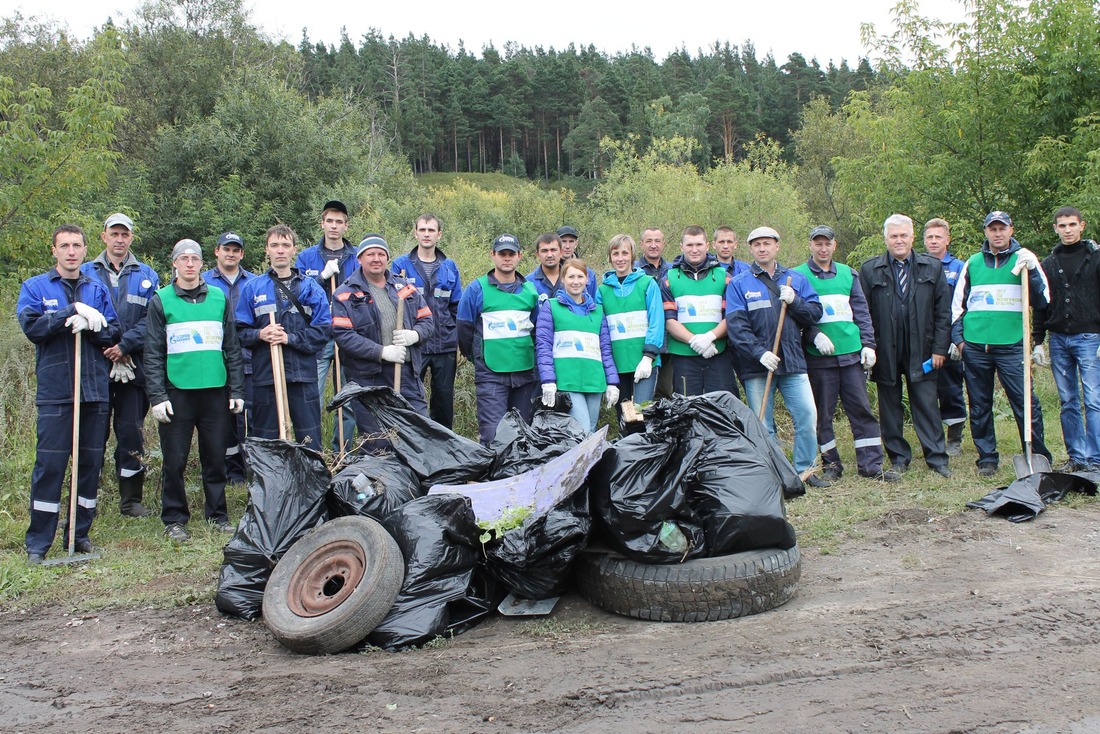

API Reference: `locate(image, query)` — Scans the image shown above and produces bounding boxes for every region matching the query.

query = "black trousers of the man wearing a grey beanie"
[160,387,229,525]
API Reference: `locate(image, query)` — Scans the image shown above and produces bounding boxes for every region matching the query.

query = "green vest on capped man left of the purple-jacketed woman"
[477,275,539,372]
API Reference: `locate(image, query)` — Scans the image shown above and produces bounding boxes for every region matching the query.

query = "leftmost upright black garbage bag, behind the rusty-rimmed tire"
[215,438,329,620]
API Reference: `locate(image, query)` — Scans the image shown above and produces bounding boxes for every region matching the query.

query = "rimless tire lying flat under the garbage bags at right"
[576,546,802,622]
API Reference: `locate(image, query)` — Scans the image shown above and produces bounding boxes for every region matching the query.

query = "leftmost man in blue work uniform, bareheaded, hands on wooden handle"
[15,224,121,563]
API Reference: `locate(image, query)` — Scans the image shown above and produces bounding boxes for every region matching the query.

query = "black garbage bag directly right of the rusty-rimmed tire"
[367,494,505,650]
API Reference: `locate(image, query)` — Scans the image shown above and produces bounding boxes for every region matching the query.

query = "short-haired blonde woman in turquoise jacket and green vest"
[596,234,664,409]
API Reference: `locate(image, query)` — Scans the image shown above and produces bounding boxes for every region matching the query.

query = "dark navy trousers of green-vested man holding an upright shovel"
[963,341,1051,467]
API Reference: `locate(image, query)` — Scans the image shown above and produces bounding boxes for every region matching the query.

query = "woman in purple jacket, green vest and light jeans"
[535,258,619,431]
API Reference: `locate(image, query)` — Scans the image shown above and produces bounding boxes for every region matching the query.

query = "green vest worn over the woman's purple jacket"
[550,298,607,393]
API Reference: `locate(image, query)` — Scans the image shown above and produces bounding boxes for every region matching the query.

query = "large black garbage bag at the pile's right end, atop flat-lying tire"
[656,392,802,556]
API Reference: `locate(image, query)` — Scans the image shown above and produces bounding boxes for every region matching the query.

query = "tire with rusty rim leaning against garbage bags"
[263,516,405,655]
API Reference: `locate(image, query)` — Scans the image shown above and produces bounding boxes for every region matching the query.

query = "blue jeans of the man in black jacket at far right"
[1048,331,1100,464]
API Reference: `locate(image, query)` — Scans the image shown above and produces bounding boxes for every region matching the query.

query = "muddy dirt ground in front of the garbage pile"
[0,504,1100,734]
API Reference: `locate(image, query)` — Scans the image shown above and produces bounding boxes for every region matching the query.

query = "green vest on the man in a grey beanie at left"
[157,284,227,390]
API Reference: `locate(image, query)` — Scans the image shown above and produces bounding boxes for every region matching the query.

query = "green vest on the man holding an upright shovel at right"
[963,252,1024,344]
